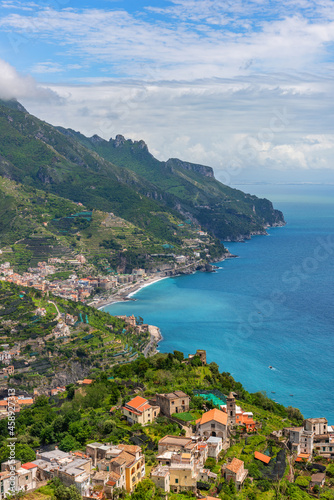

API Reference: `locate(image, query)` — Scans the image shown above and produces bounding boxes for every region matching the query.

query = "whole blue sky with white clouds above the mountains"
[0,0,334,186]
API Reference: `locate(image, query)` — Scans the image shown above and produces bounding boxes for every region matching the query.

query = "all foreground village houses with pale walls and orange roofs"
[0,380,334,500]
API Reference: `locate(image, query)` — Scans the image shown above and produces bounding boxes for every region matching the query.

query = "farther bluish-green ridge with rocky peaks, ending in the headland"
[59,128,284,239]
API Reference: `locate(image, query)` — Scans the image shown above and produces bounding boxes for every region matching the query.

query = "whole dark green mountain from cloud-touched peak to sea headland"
[0,101,284,246]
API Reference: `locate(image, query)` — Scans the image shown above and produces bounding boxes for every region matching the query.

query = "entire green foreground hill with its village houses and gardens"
[0,350,334,500]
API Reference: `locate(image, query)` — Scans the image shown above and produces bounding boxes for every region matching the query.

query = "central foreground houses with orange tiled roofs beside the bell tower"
[122,390,248,492]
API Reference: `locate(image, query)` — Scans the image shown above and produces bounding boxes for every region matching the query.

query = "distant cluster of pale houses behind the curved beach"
[0,255,146,302]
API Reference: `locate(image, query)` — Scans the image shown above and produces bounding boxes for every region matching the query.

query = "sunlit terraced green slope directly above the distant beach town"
[0,177,218,271]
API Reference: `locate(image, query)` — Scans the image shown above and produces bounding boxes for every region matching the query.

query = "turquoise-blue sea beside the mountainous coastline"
[105,185,334,425]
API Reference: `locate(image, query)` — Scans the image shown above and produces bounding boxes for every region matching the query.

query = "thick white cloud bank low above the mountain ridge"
[16,76,334,187]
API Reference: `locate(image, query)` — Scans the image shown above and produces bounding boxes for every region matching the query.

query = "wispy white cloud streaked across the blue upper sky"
[0,5,334,81]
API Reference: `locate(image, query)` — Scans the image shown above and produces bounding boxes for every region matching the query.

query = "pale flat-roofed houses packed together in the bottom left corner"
[0,443,145,500]
